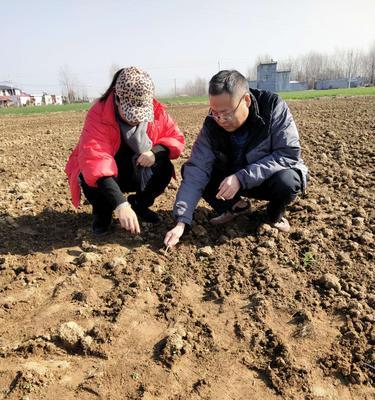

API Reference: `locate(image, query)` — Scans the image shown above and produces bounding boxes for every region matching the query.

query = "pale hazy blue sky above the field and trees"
[0,0,375,96]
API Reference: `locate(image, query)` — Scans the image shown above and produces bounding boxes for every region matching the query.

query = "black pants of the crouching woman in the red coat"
[80,155,174,214]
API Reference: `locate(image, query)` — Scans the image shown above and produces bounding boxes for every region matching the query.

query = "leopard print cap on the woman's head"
[115,67,154,124]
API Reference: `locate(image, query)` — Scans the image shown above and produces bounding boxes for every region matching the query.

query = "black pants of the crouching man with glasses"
[202,169,302,222]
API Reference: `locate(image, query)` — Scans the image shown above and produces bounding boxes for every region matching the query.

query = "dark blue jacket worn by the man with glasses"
[173,89,308,224]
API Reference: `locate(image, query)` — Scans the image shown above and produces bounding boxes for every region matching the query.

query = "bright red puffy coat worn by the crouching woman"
[65,95,185,207]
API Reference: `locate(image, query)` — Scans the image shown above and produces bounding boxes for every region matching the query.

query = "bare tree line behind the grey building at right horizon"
[247,42,375,87]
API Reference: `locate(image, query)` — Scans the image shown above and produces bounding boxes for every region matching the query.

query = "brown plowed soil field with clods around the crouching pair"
[0,96,375,400]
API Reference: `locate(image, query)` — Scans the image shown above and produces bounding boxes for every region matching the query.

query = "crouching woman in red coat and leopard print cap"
[65,67,184,235]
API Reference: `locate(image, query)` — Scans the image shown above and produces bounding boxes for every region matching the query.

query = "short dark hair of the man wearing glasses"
[208,69,249,96]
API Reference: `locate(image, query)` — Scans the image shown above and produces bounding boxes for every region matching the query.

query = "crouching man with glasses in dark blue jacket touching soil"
[164,70,307,246]
